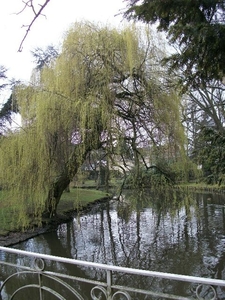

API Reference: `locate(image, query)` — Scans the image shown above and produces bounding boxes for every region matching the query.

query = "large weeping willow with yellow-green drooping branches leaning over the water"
[0,23,183,226]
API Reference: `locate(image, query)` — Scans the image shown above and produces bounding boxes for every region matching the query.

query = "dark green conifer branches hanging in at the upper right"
[125,0,225,85]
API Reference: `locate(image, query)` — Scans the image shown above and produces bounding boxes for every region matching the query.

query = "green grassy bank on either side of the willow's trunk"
[0,188,107,235]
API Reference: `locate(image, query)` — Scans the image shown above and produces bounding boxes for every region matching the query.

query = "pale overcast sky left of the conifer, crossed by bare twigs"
[0,0,125,84]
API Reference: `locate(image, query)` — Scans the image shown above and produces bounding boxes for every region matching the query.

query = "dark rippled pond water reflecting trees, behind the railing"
[2,191,225,299]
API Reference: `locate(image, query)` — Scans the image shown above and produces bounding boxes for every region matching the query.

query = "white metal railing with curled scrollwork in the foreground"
[0,247,225,300]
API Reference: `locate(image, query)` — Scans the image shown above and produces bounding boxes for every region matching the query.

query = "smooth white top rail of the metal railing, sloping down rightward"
[0,246,225,286]
